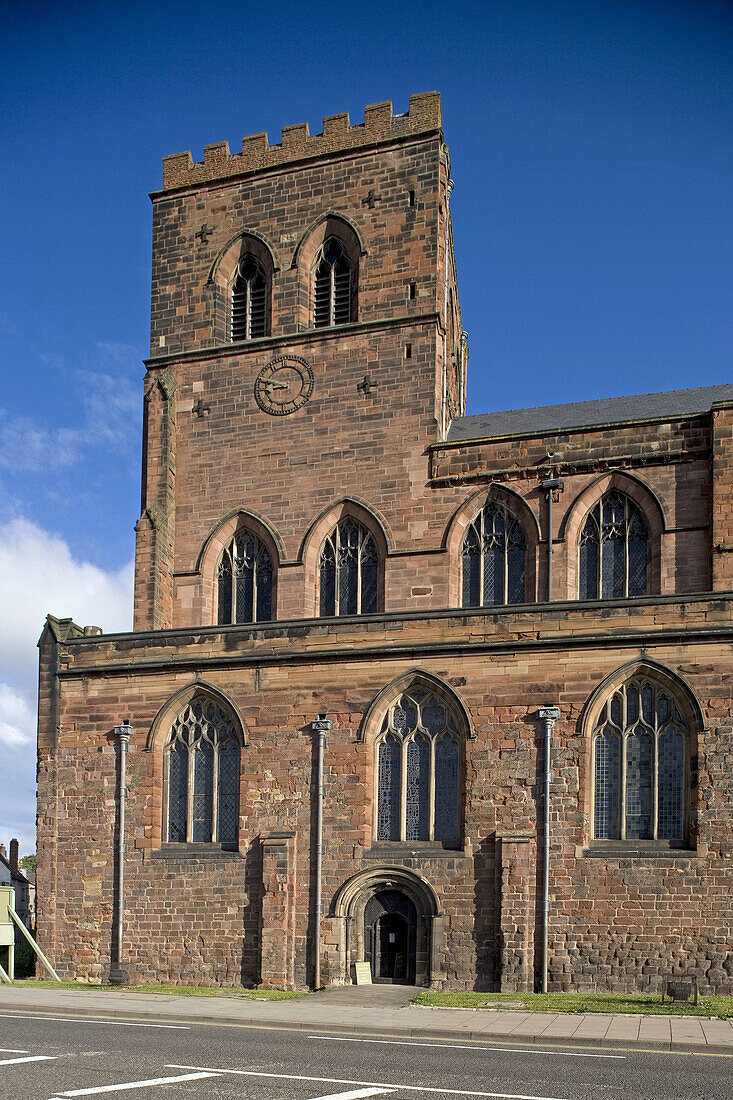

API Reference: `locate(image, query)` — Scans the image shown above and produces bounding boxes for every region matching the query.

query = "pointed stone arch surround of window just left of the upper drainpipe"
[442,482,540,607]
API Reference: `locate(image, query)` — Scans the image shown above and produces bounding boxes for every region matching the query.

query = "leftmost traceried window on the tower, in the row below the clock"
[217,530,274,626]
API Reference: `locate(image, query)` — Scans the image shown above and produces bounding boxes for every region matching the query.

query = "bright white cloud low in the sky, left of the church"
[0,519,133,851]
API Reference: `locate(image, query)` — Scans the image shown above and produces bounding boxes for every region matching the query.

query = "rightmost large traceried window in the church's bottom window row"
[593,677,689,844]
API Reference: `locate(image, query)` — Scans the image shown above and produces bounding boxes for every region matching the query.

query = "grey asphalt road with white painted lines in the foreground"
[0,1012,733,1100]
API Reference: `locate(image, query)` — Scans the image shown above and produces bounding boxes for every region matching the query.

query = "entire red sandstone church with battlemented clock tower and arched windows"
[37,92,733,993]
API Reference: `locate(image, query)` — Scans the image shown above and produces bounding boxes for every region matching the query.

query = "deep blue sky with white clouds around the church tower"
[0,0,733,849]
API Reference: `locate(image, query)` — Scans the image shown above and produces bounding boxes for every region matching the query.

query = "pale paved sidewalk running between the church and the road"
[0,986,733,1054]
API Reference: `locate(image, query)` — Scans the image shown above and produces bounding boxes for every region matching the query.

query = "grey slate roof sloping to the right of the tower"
[447,385,733,443]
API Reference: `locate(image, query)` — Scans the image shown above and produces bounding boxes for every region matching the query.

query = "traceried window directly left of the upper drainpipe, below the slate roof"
[462,503,527,607]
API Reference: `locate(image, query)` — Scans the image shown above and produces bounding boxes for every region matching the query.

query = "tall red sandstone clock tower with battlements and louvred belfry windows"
[134,92,467,630]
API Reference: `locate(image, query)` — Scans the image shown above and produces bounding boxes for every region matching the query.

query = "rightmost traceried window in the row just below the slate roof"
[578,490,649,600]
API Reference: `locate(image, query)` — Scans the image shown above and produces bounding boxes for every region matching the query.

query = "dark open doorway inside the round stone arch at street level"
[364,890,417,986]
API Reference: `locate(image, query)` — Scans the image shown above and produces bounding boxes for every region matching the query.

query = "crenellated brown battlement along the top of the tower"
[163,91,442,190]
